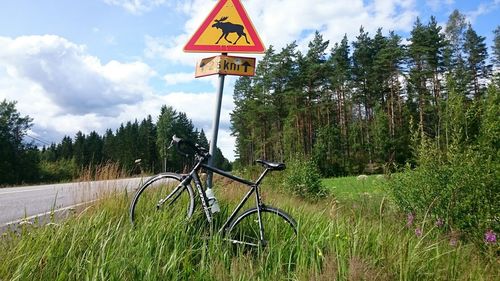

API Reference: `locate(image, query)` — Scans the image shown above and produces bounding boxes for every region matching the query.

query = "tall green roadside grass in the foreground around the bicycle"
[0,174,500,280]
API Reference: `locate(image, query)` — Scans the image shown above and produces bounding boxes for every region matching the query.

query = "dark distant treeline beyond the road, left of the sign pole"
[0,101,231,185]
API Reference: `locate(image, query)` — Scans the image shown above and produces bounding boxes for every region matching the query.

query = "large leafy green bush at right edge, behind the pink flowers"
[389,141,500,239]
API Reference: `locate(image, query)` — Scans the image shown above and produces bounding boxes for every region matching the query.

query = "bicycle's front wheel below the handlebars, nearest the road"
[129,173,195,225]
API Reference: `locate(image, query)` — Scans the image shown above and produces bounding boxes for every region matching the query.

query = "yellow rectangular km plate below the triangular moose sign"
[195,56,255,78]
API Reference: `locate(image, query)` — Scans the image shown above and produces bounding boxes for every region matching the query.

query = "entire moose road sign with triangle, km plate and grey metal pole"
[184,0,265,212]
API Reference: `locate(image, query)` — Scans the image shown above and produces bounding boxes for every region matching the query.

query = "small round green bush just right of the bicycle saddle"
[283,158,326,199]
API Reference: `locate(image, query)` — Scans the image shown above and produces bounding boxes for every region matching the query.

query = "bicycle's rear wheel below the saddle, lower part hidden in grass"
[226,206,297,246]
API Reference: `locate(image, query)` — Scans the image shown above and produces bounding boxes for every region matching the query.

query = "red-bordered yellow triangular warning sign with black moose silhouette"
[184,0,265,53]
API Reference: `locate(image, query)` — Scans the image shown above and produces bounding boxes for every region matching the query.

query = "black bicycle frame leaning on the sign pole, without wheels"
[181,158,270,234]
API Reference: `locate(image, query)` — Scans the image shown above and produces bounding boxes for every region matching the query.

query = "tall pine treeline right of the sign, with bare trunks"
[231,11,500,176]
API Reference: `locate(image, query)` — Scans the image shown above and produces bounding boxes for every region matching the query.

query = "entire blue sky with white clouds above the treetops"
[0,0,500,160]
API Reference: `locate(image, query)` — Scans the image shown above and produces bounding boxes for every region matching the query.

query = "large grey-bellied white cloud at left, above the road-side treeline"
[0,35,155,134]
